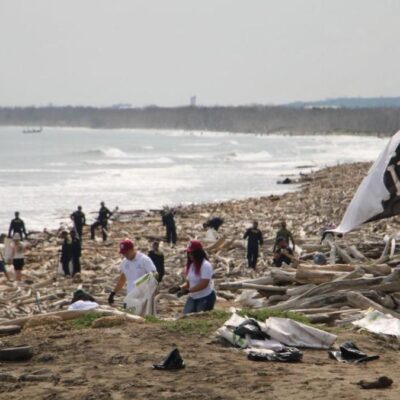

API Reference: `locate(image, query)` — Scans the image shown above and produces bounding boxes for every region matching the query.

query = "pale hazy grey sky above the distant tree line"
[0,0,400,106]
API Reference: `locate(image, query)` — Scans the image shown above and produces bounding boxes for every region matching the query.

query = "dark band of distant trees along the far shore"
[0,106,400,135]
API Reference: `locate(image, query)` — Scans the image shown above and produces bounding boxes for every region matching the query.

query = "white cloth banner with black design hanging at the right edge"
[330,131,400,233]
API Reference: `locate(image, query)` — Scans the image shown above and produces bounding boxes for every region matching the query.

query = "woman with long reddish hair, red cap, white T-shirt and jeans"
[179,240,216,314]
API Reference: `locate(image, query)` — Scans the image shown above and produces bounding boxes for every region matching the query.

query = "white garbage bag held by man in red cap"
[124,273,158,317]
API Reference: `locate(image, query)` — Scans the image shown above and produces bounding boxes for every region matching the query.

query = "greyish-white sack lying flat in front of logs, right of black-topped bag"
[262,317,336,349]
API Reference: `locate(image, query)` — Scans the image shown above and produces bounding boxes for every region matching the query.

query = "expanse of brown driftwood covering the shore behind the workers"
[0,163,400,322]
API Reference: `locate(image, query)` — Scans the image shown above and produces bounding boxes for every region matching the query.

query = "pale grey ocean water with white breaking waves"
[0,127,387,232]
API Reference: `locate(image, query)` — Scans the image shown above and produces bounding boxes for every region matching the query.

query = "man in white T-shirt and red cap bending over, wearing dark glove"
[108,239,157,305]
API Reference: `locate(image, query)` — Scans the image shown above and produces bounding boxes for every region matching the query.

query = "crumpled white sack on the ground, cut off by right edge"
[353,310,400,338]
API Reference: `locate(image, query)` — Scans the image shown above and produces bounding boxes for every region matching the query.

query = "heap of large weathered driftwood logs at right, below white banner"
[219,234,400,324]
